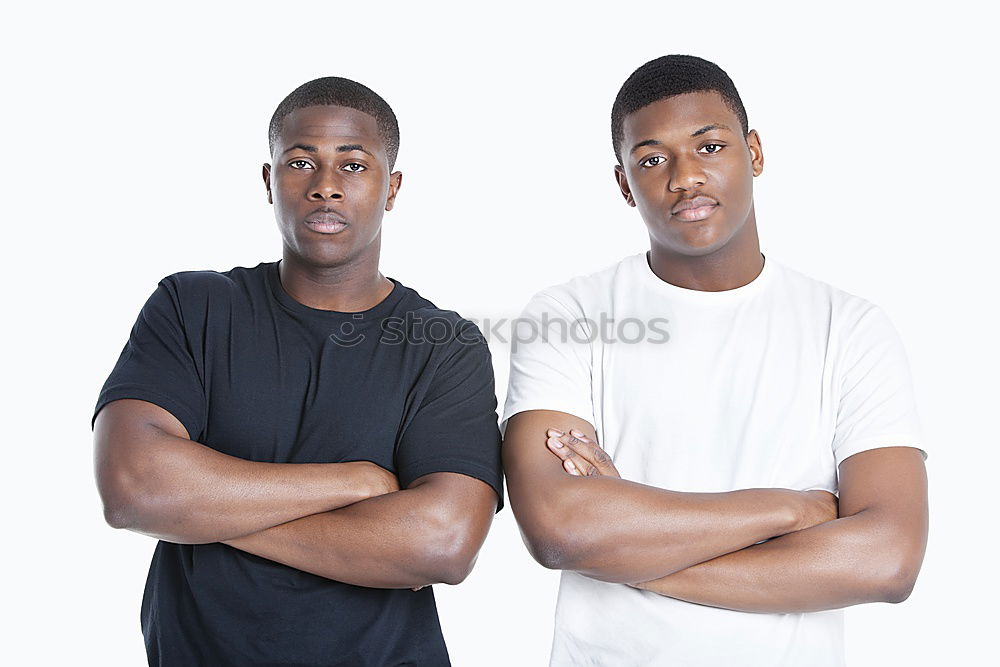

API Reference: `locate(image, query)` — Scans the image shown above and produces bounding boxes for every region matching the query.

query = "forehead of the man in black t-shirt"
[276,105,385,153]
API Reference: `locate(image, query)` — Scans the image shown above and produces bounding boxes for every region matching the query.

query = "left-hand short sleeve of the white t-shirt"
[501,292,596,434]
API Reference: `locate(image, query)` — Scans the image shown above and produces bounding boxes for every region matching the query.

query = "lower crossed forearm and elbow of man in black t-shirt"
[225,473,496,588]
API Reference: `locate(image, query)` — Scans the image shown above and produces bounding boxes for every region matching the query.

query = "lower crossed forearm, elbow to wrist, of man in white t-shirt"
[640,512,916,613]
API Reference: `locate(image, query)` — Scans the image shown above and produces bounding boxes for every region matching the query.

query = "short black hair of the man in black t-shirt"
[267,76,399,171]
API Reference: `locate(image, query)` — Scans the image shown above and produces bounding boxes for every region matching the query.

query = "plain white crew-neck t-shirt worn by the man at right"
[503,253,926,667]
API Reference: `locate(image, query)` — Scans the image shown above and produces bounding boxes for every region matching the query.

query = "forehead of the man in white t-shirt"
[622,90,741,143]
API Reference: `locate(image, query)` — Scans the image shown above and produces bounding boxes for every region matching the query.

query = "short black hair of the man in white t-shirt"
[611,55,750,164]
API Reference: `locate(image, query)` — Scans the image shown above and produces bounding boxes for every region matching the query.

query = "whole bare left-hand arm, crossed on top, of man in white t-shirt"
[504,410,836,583]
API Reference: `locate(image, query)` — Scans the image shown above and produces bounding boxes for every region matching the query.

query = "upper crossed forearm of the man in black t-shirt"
[107,435,378,543]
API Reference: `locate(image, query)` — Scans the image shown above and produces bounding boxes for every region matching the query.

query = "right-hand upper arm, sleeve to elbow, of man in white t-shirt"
[840,447,928,599]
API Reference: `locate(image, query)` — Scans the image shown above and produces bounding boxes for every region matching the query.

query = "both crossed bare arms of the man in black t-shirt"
[94,399,497,588]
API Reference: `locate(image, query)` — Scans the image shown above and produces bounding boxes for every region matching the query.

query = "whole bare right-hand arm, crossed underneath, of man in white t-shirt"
[639,447,927,613]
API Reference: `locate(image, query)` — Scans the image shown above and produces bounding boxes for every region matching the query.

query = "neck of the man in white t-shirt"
[647,214,764,292]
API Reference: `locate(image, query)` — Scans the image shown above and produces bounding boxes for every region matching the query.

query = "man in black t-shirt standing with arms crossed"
[92,77,502,666]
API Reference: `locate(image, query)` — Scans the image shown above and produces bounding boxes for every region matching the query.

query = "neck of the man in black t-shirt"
[278,247,393,313]
